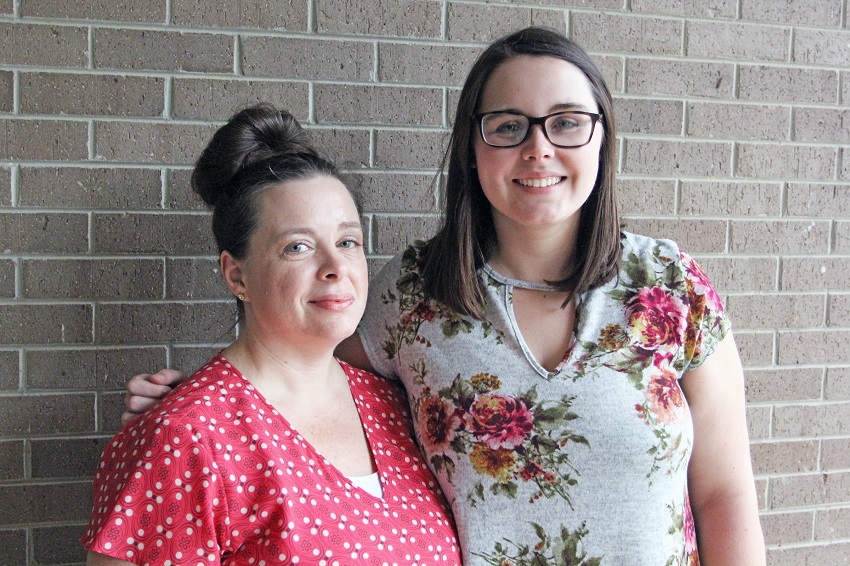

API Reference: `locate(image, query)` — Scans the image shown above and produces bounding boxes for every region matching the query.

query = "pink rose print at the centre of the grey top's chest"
[467,394,534,450]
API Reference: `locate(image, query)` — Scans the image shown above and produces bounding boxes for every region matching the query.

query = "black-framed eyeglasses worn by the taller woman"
[474,111,602,148]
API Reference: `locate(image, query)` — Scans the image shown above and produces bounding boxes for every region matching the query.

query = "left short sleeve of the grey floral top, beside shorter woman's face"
[357,252,412,379]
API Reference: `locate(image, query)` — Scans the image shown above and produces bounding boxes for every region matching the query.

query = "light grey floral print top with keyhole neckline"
[358,232,729,566]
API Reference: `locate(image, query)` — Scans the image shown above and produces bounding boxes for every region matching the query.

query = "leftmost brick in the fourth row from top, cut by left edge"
[0,119,88,161]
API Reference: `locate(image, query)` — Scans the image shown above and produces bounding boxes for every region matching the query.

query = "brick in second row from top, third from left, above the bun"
[241,36,375,81]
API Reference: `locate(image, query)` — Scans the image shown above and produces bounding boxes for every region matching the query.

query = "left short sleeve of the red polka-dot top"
[81,417,226,565]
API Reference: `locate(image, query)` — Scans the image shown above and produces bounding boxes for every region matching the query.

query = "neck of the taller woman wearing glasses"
[489,218,578,283]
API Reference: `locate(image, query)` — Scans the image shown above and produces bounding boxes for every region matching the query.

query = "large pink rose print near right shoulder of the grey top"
[626,287,687,350]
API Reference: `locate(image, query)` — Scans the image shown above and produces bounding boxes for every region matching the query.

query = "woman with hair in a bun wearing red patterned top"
[82,105,460,565]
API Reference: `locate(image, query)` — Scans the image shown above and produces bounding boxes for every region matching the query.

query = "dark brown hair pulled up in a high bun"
[192,104,360,317]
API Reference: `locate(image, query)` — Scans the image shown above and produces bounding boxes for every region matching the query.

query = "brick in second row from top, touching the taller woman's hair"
[378,42,481,86]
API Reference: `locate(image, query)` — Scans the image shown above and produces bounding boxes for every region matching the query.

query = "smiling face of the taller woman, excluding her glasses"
[473,55,604,242]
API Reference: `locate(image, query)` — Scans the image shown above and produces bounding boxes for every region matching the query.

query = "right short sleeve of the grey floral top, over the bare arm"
[679,251,731,370]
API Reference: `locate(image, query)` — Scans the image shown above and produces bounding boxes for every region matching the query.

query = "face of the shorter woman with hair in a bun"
[222,176,367,348]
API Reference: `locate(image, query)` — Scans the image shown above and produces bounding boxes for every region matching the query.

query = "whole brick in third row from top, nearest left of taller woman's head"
[314,84,443,127]
